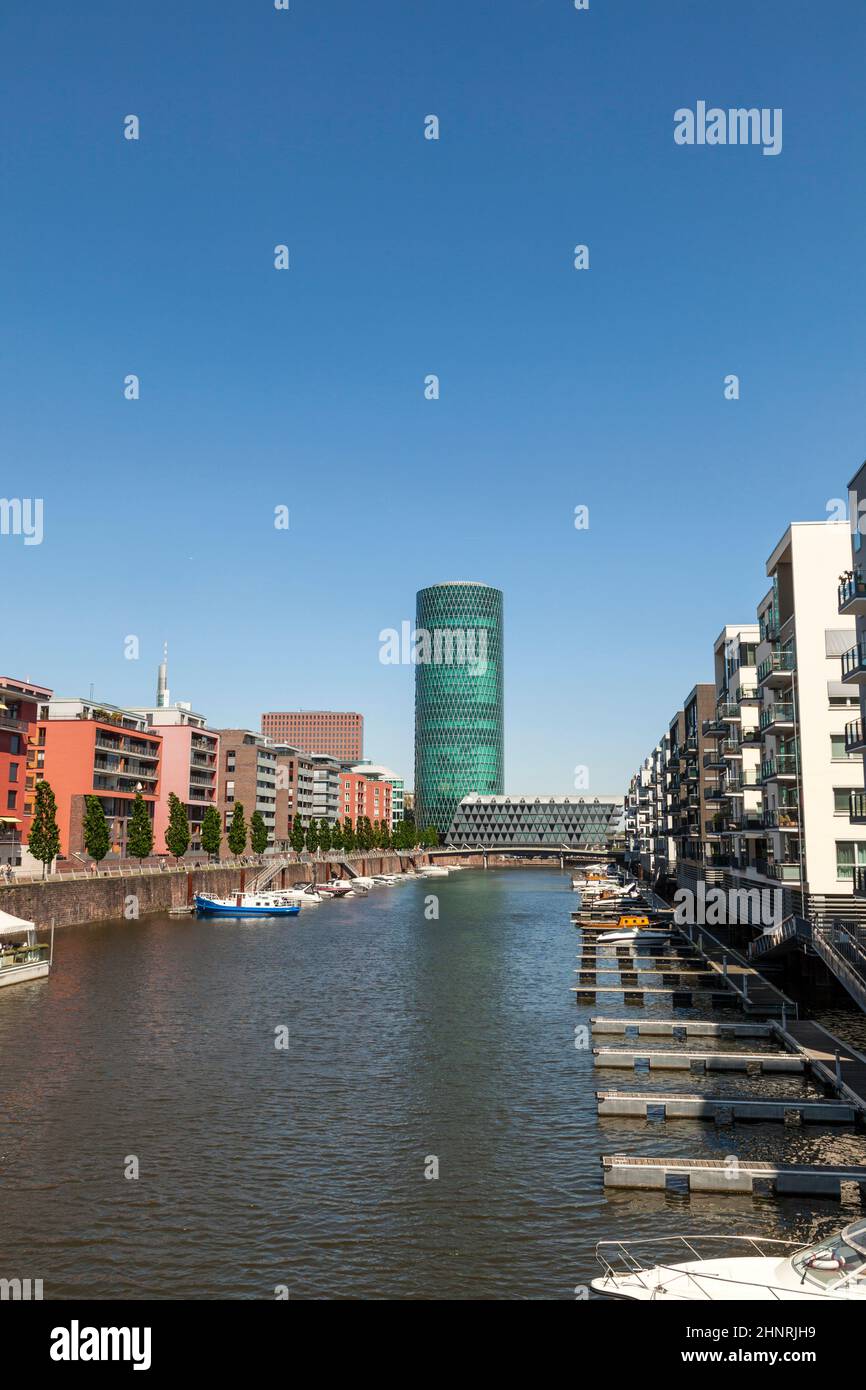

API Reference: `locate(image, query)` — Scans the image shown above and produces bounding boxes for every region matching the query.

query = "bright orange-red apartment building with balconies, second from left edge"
[33,698,163,862]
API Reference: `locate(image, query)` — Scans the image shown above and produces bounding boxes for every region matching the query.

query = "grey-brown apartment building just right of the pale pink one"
[214,728,289,855]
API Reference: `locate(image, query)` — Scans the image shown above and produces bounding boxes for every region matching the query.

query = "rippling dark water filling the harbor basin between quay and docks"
[0,869,866,1298]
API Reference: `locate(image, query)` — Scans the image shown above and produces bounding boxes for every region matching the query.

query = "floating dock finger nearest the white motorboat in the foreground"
[602,1154,866,1202]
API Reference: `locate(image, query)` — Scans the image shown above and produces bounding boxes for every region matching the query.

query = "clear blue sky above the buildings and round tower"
[0,0,866,792]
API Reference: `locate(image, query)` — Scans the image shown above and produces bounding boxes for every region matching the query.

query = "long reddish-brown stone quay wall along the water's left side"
[0,853,428,929]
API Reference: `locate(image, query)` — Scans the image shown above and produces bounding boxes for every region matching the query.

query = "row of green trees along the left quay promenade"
[28,781,439,877]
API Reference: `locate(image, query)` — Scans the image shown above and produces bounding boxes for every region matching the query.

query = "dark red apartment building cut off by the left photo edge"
[0,676,53,867]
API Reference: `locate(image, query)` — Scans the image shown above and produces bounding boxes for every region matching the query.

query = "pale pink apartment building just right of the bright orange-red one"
[133,703,220,853]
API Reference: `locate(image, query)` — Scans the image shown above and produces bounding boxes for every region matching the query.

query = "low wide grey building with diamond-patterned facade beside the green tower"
[446,795,623,849]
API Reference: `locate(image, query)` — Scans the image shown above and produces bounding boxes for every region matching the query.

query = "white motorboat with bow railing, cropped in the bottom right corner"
[592,1219,866,1302]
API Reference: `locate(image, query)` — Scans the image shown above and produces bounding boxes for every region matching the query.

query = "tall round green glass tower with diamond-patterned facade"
[414,581,505,835]
